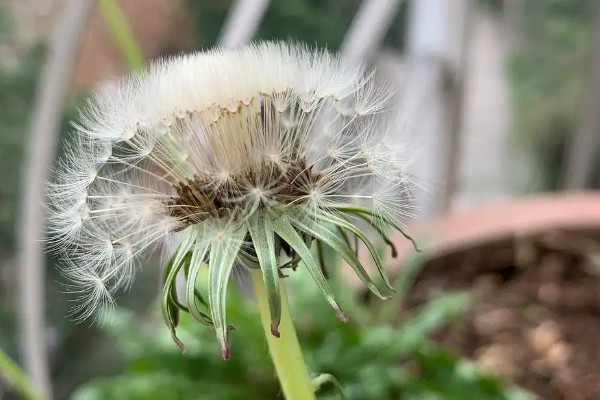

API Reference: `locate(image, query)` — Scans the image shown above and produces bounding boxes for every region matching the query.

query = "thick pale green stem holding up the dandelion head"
[250,269,316,400]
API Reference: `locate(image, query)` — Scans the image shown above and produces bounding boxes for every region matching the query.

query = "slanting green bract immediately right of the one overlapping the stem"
[273,214,348,321]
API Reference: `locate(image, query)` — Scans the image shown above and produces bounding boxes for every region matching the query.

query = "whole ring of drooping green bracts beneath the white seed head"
[162,206,412,358]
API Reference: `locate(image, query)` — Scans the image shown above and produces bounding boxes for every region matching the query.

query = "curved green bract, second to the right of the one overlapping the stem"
[291,212,389,300]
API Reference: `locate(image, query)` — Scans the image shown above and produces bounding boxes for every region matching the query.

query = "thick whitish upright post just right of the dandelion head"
[402,0,471,215]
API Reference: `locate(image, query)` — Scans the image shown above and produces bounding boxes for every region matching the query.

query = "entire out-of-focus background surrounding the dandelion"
[0,0,600,400]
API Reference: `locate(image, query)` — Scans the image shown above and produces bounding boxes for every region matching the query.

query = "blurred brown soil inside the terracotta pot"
[412,232,600,400]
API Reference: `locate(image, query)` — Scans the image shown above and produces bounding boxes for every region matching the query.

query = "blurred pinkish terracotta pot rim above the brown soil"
[390,192,600,265]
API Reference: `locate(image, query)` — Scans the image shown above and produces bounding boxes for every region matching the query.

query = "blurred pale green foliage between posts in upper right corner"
[509,0,598,189]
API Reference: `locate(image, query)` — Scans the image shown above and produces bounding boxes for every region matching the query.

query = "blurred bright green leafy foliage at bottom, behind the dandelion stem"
[72,256,533,400]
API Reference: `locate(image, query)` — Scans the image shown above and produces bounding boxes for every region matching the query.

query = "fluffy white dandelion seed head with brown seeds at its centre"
[48,43,411,328]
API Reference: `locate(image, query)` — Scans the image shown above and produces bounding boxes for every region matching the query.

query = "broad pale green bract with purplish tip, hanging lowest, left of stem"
[208,227,246,360]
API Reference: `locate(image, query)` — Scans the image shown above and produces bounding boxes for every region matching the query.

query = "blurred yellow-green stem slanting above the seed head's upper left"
[99,0,144,71]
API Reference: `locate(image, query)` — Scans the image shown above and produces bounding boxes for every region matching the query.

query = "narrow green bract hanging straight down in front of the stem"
[248,212,281,337]
